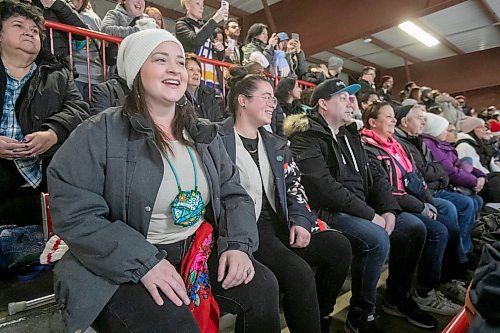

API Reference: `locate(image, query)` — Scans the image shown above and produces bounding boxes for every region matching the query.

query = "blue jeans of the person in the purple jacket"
[434,191,483,256]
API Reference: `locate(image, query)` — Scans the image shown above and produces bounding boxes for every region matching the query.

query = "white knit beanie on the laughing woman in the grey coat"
[116,29,184,88]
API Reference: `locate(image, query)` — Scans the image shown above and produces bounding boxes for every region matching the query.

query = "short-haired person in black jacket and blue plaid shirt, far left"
[0,1,89,225]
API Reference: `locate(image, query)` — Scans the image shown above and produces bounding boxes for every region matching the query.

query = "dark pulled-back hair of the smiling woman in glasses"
[228,66,270,119]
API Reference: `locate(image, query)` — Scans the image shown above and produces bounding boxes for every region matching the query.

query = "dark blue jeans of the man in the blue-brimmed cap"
[319,211,425,316]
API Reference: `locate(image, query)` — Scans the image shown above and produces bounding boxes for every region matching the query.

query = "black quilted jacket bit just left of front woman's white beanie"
[90,75,130,114]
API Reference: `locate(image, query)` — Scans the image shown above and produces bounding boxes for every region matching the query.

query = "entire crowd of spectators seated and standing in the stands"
[0,0,500,333]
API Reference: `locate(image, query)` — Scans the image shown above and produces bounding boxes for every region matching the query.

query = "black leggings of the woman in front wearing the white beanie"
[92,239,280,333]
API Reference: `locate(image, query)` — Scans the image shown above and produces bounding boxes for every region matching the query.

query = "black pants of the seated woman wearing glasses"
[254,218,351,333]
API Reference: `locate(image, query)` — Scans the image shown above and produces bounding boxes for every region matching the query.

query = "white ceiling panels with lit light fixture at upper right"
[312,0,500,71]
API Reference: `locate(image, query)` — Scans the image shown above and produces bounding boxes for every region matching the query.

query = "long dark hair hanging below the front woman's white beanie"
[122,74,195,153]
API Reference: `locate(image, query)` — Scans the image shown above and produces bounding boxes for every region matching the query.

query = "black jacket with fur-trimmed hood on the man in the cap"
[284,114,400,220]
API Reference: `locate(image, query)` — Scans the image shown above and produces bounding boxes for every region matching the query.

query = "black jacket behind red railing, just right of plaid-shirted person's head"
[33,0,88,57]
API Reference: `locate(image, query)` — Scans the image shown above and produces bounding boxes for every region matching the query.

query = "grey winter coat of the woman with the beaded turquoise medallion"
[48,107,258,332]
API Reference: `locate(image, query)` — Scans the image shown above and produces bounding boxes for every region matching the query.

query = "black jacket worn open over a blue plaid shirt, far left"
[0,49,89,157]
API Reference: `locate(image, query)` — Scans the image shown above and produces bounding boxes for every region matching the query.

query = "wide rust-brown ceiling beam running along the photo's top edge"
[249,0,465,54]
